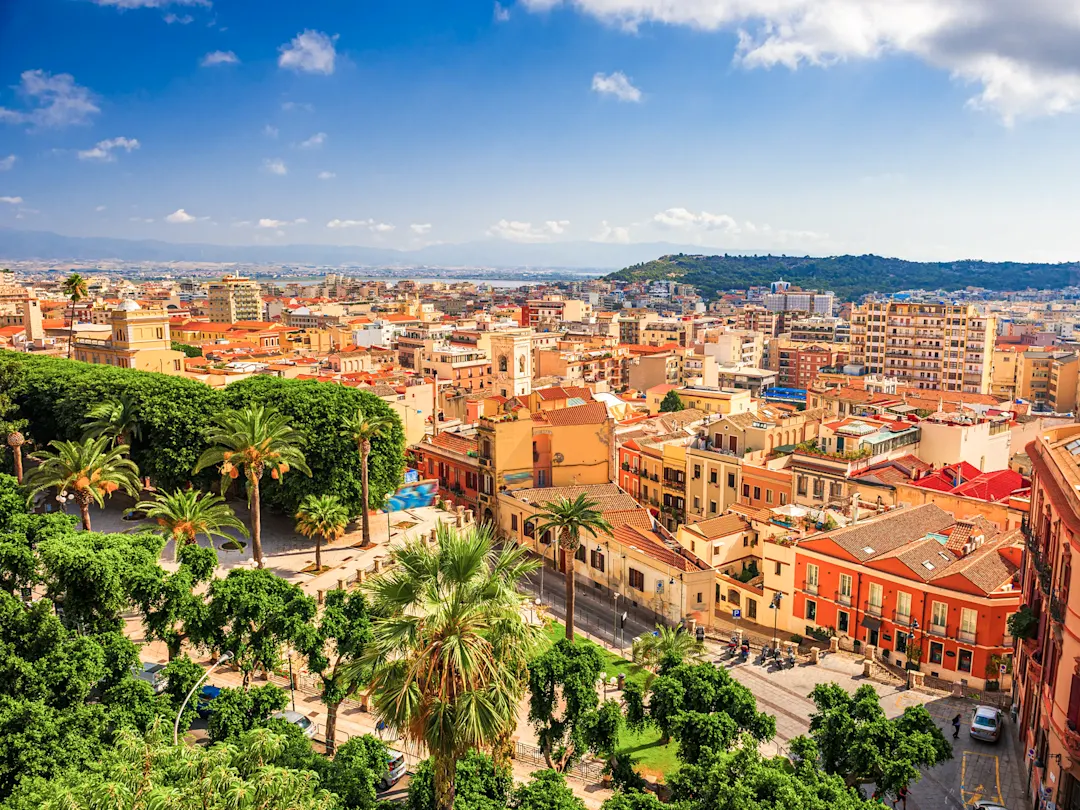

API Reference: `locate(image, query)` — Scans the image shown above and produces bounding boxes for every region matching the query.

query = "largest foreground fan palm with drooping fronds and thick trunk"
[356,525,540,810]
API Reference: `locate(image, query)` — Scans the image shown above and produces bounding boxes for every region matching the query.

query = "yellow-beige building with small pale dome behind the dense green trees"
[73,300,184,375]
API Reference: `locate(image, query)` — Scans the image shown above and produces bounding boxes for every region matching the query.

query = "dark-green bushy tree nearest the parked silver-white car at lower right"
[810,684,953,796]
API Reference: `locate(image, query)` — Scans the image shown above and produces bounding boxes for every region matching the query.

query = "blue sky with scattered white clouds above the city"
[0,0,1080,260]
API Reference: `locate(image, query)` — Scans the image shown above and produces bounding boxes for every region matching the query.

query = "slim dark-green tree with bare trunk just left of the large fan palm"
[305,590,373,756]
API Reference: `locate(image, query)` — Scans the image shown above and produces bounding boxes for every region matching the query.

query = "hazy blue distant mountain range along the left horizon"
[0,228,721,270]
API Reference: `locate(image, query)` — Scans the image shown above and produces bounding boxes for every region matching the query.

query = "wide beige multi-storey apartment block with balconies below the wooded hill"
[851,300,996,394]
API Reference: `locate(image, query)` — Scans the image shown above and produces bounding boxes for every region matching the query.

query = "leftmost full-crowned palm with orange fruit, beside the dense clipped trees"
[26,436,139,531]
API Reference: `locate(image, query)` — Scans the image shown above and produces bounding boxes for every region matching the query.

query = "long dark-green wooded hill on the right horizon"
[607,254,1080,299]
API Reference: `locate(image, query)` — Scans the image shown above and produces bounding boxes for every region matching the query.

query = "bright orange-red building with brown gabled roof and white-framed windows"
[791,503,1022,689]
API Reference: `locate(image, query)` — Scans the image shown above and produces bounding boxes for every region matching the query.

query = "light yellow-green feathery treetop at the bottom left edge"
[33,724,340,810]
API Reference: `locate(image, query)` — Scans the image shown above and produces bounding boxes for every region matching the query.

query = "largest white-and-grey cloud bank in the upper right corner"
[521,0,1080,123]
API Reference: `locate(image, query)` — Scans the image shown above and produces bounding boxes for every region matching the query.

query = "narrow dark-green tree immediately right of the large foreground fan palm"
[529,638,618,772]
